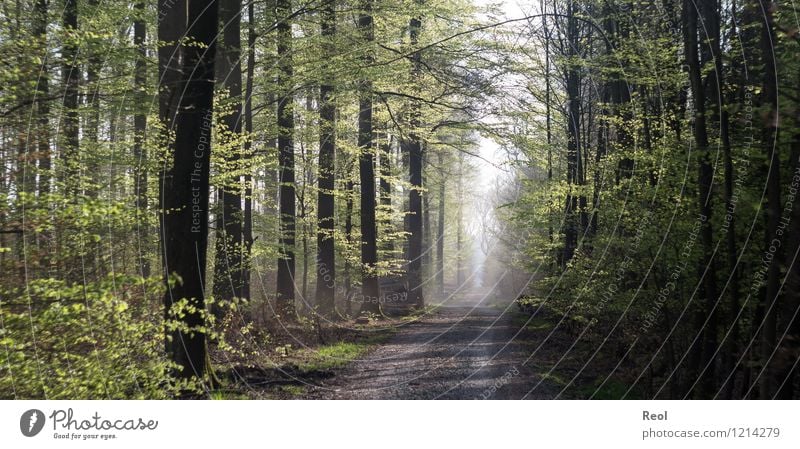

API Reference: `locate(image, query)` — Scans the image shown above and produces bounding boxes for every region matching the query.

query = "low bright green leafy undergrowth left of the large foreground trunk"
[0,275,178,399]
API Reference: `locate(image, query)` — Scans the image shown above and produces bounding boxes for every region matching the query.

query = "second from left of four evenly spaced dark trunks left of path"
[316,2,336,316]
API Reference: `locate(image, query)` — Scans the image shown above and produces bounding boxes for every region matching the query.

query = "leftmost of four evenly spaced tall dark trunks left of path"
[277,0,296,320]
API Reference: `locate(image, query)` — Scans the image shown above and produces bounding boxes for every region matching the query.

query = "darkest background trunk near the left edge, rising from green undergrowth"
[60,0,81,196]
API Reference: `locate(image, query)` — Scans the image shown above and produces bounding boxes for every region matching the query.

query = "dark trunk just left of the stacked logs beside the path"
[358,0,381,313]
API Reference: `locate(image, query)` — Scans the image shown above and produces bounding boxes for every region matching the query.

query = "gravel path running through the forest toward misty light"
[308,291,558,399]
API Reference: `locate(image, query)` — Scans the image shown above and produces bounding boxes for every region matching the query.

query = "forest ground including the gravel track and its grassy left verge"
[219,291,592,399]
